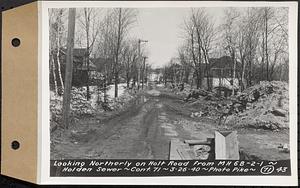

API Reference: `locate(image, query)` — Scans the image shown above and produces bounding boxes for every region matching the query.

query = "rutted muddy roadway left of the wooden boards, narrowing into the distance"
[55,88,202,159]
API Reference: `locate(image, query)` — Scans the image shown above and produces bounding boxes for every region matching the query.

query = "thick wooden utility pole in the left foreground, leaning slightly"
[63,8,76,129]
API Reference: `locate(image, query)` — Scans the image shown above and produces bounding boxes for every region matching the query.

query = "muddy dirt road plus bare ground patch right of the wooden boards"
[51,87,289,160]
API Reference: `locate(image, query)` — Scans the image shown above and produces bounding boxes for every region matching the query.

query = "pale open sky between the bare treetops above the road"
[130,8,223,68]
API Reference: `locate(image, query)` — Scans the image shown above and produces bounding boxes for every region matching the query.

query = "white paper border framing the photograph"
[38,1,298,186]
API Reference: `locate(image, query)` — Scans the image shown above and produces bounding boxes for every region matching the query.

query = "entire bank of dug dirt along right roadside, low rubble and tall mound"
[185,81,289,130]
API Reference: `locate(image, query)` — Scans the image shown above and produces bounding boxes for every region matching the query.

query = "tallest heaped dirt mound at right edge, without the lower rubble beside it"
[225,81,289,130]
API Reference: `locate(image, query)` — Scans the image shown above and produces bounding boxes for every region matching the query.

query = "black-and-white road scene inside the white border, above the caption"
[48,1,296,182]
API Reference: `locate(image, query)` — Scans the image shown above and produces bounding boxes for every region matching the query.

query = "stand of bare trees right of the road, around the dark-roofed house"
[169,7,288,95]
